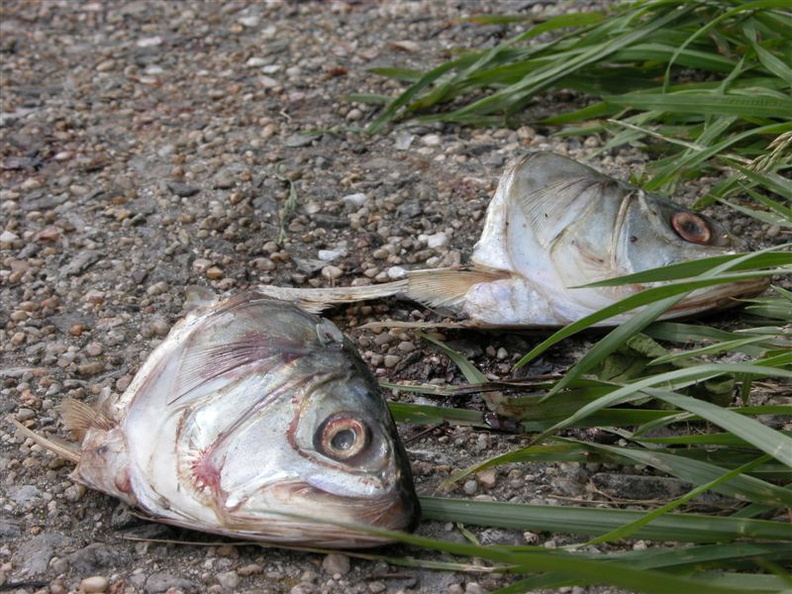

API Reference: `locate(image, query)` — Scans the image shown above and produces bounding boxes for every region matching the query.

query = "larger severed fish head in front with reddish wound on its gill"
[21,293,420,548]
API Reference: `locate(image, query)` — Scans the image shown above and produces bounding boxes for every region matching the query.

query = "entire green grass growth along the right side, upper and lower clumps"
[354,0,792,594]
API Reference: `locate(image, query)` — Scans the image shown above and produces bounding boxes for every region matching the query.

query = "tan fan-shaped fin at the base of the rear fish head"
[406,268,510,311]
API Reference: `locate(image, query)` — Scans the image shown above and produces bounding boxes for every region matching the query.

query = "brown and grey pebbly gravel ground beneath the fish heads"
[0,0,784,594]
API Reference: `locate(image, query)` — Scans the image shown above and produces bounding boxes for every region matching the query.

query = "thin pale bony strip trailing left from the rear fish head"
[255,279,407,313]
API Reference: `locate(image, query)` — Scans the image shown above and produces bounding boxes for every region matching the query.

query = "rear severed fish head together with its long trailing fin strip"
[257,152,767,328]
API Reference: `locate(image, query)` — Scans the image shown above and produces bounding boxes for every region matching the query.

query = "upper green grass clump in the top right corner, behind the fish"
[356,0,792,201]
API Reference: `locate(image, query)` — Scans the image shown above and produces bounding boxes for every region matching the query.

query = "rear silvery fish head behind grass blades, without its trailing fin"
[473,152,766,325]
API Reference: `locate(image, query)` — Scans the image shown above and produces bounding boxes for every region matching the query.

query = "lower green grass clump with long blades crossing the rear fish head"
[380,253,792,594]
